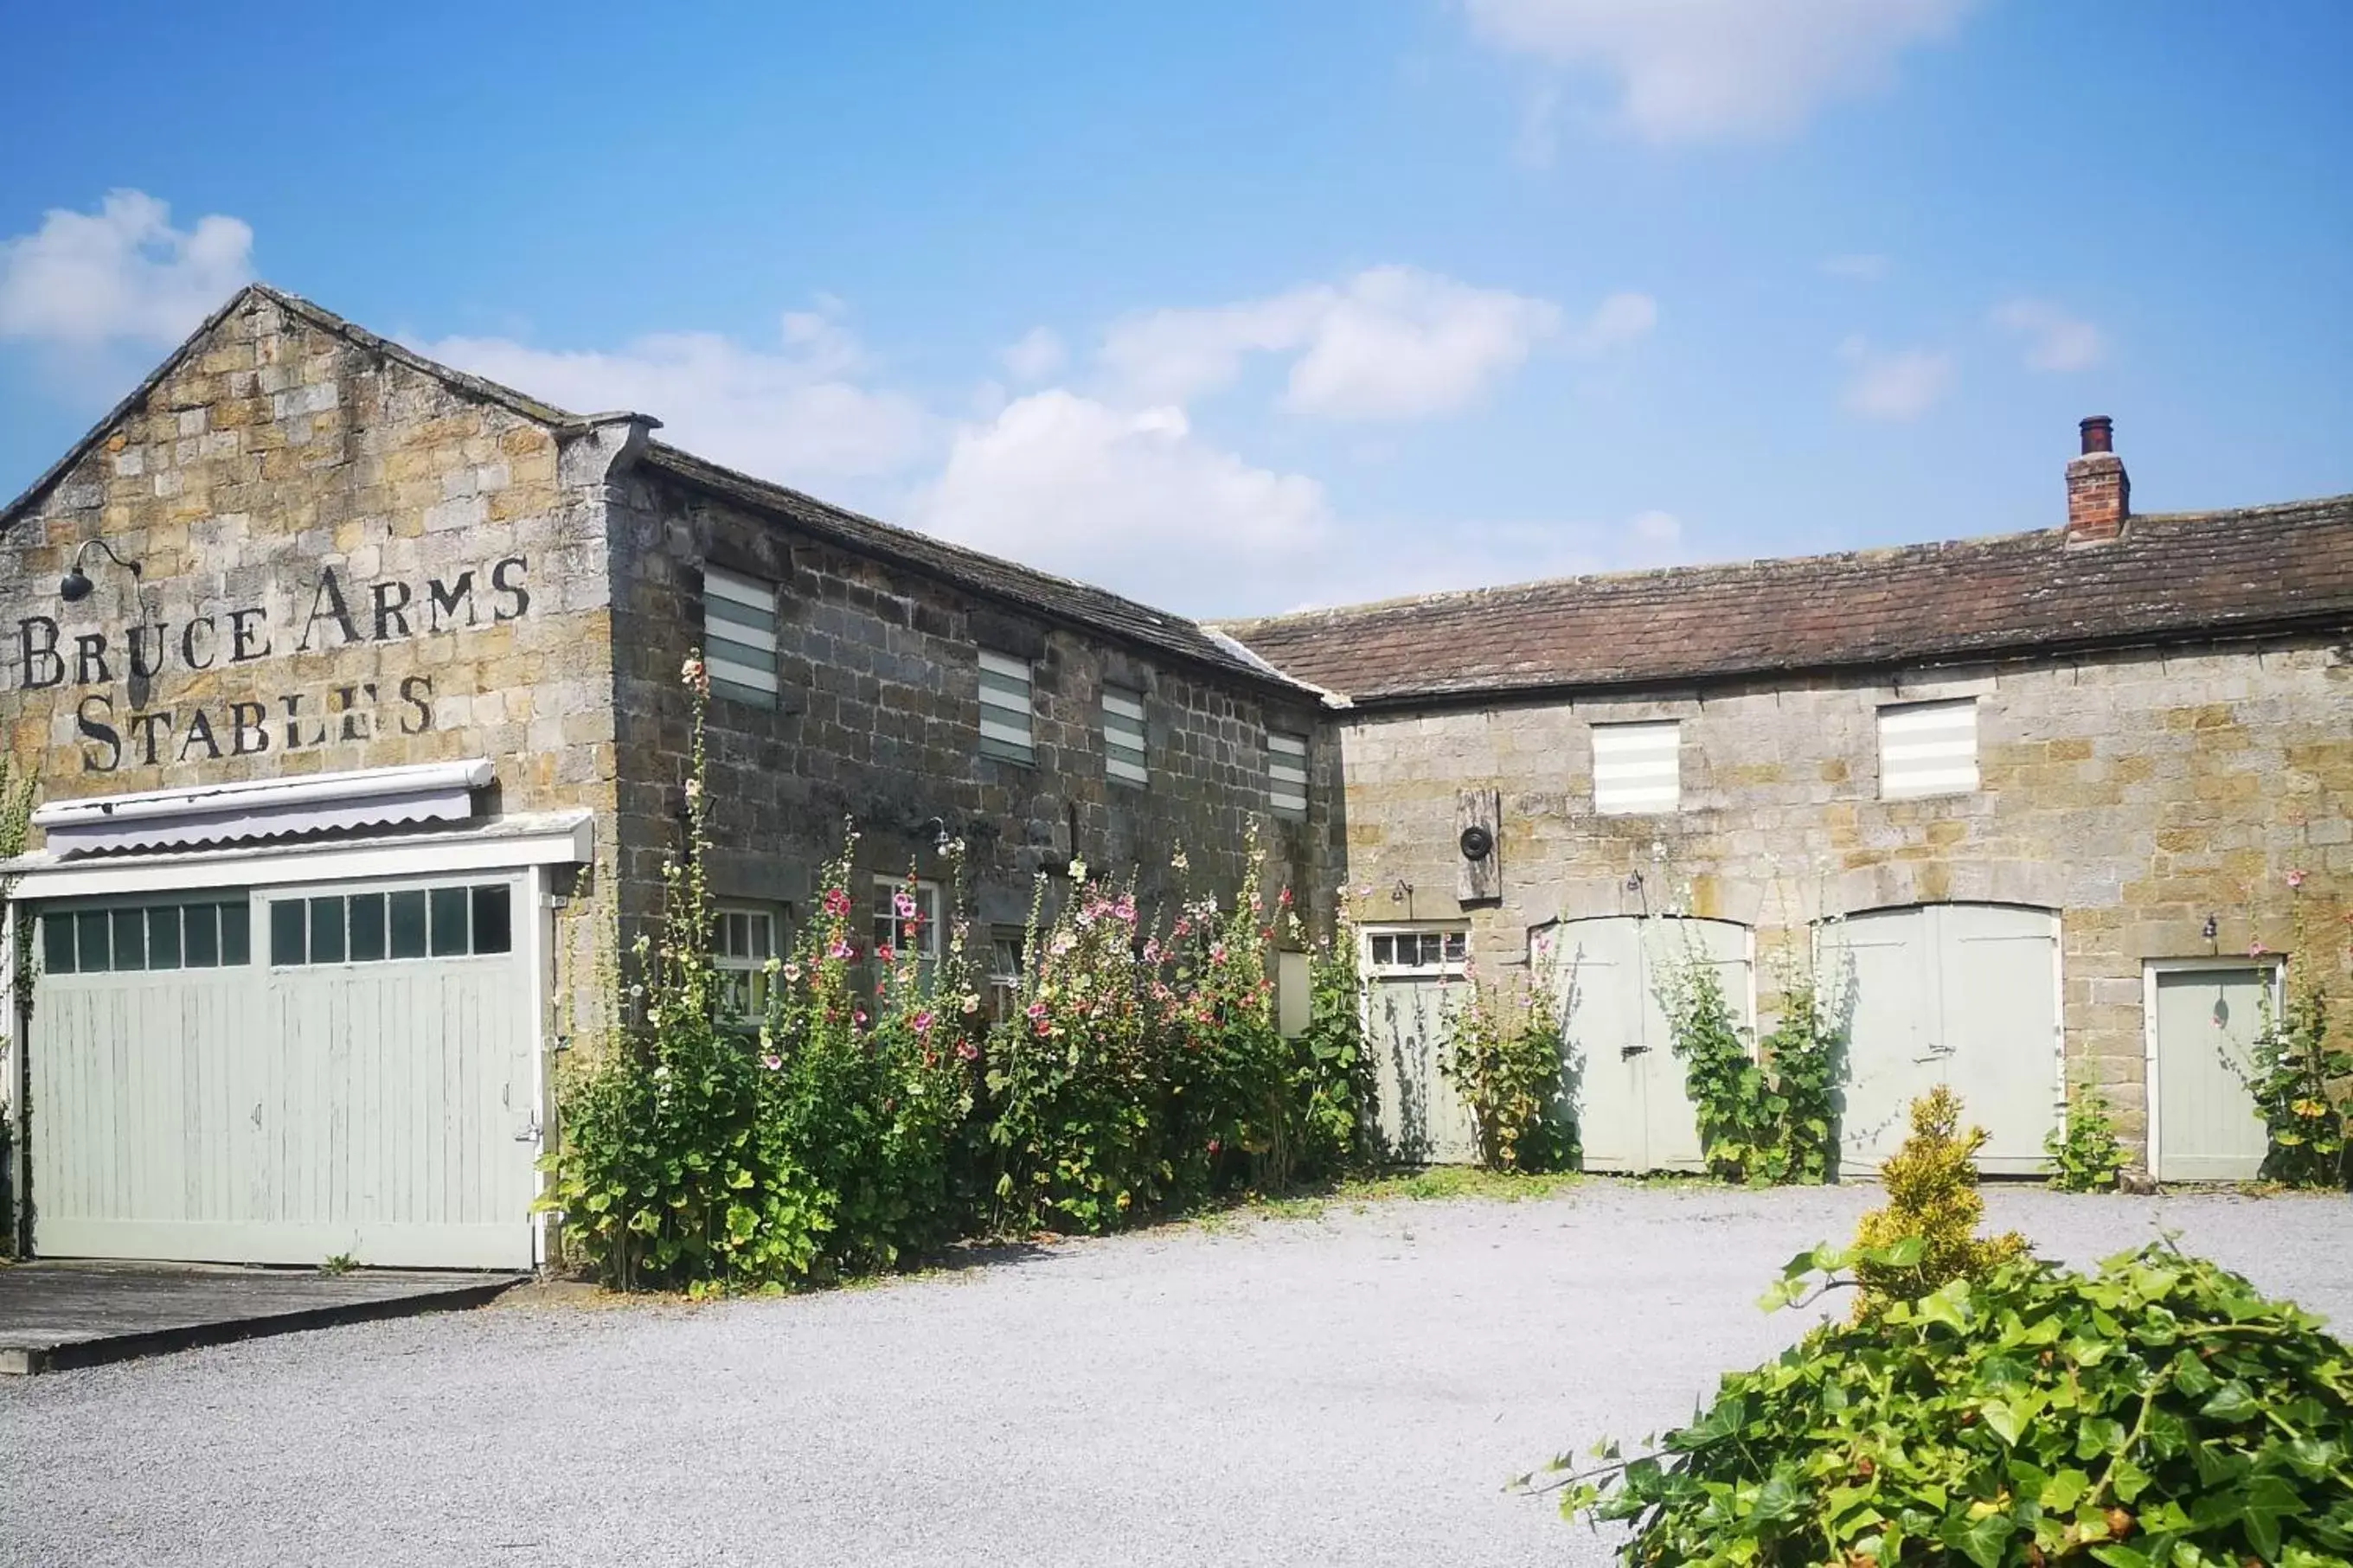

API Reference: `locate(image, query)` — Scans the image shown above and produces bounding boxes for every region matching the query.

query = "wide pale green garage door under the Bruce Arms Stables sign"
[29,877,539,1267]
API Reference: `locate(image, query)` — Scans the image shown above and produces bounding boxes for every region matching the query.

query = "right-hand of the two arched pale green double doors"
[1824,903,2059,1175]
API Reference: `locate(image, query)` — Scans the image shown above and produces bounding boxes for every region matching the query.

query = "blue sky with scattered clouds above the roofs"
[0,0,2353,613]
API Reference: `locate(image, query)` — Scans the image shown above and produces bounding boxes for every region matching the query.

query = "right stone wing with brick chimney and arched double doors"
[1226,419,2353,1181]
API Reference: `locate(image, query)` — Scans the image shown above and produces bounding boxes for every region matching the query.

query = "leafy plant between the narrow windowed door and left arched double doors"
[1438,963,1572,1171]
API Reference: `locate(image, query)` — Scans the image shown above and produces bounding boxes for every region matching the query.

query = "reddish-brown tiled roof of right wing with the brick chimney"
[1219,496,2353,703]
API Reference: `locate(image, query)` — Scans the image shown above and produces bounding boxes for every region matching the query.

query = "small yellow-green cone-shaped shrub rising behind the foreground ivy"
[1854,1084,2026,1316]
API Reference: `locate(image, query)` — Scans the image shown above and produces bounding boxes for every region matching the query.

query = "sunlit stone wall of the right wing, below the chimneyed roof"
[1341,639,2353,1166]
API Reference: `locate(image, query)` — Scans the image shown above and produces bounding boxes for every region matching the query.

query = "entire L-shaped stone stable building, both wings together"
[0,287,2353,1267]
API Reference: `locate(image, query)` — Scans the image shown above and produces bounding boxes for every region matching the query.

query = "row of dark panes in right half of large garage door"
[272,881,516,969]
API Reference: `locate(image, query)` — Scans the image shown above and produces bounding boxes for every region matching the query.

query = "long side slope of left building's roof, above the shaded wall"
[643,442,1323,701]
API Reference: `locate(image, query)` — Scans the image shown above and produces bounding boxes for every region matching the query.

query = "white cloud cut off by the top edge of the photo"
[1464,0,1974,141]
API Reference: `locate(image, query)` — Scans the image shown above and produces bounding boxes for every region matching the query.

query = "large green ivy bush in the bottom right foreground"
[1546,1238,2353,1568]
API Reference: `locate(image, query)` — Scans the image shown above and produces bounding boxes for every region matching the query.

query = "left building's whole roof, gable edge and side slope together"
[0,282,1323,701]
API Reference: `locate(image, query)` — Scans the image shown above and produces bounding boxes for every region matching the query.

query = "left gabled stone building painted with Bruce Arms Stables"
[0,287,1337,1267]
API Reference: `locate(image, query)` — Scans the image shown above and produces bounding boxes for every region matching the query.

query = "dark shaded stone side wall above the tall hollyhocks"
[617,470,1337,959]
